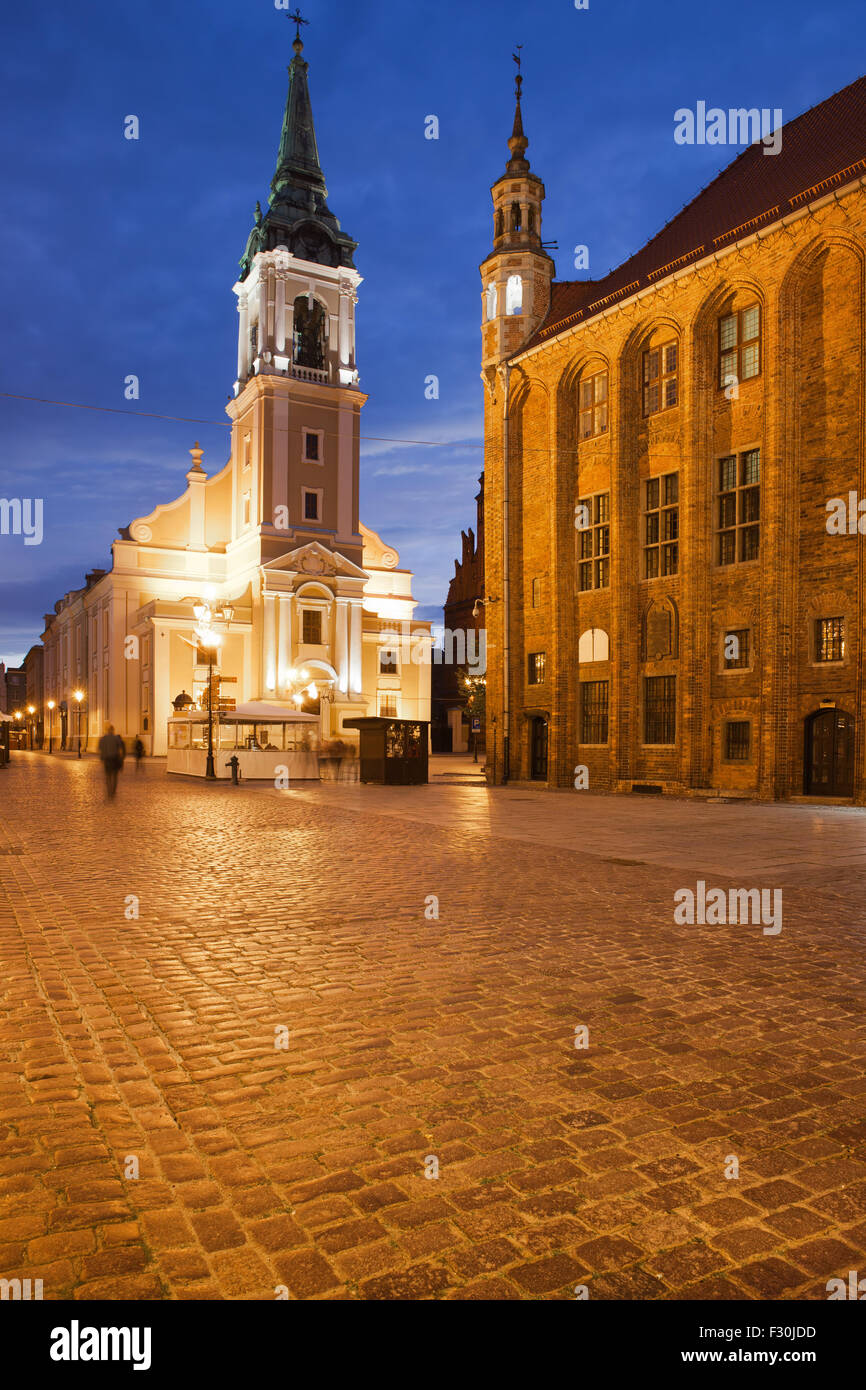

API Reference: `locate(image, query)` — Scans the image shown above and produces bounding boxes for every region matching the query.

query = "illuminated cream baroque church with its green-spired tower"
[43,36,431,755]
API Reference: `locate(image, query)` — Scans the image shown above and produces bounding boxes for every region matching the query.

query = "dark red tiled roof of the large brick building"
[516,76,866,356]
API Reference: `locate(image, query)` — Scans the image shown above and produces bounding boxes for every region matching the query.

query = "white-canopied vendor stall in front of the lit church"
[165,701,320,783]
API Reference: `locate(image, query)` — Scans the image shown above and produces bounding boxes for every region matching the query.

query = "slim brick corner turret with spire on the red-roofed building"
[481,60,555,381]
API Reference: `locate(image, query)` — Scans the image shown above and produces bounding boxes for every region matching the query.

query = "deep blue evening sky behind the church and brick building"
[0,0,866,663]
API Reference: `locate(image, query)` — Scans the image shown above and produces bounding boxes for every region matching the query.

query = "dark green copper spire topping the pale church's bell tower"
[240,14,357,279]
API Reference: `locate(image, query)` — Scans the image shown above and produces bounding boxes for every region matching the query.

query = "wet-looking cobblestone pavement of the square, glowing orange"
[0,753,866,1300]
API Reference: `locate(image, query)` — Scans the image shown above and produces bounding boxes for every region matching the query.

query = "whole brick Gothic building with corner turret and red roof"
[481,70,866,803]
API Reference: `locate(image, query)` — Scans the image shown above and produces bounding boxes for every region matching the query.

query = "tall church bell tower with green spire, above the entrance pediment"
[227,21,367,566]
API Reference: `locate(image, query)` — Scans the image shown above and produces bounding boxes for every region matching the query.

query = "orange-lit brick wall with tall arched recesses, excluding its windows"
[482,182,866,801]
